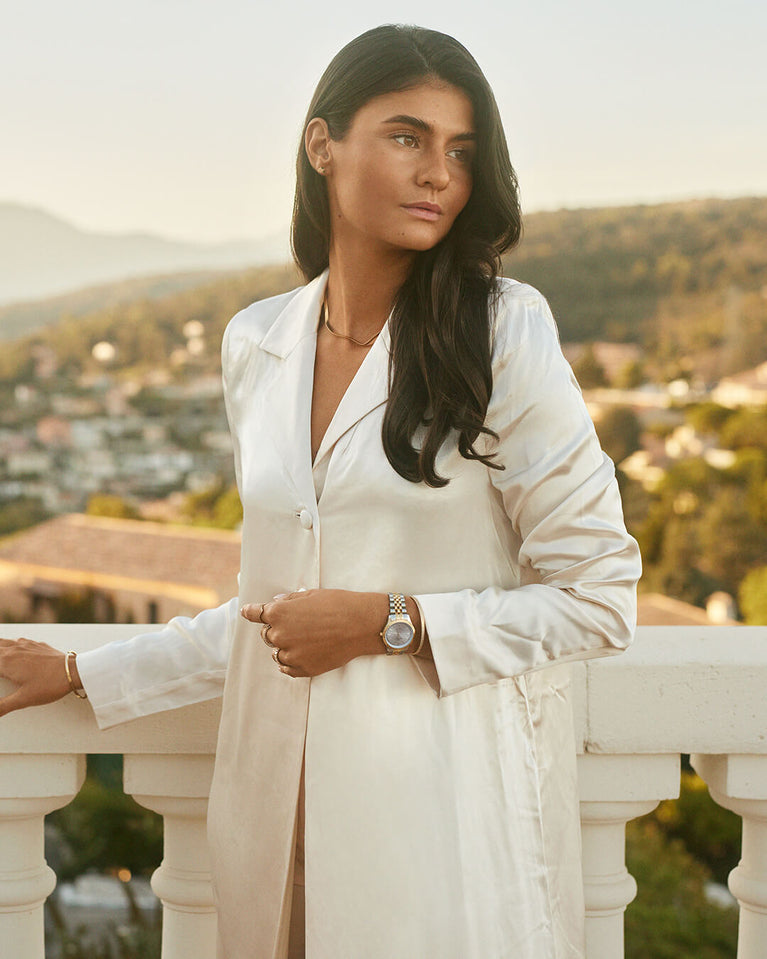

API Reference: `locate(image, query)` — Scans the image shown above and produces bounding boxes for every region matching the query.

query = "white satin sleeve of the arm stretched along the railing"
[77,327,241,729]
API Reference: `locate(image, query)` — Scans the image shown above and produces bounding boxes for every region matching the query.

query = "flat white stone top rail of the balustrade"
[0,624,767,754]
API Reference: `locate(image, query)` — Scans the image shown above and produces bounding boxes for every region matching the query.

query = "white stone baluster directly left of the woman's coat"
[123,755,217,959]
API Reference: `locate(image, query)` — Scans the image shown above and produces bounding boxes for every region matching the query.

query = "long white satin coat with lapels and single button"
[78,273,640,959]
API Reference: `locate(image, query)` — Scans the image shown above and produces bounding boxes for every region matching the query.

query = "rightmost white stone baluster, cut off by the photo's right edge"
[690,753,767,959]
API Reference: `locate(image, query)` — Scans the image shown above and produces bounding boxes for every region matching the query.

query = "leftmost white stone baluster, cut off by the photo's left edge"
[0,754,85,959]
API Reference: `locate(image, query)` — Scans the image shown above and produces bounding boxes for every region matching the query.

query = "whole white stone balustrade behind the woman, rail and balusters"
[0,625,767,959]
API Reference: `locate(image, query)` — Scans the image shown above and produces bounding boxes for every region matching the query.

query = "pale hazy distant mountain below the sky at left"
[0,203,287,303]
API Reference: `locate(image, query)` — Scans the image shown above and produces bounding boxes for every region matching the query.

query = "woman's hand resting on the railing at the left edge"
[0,639,80,716]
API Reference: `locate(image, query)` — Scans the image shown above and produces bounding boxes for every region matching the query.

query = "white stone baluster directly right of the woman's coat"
[578,753,679,959]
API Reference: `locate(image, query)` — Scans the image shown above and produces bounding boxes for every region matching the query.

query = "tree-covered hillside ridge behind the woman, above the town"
[0,198,767,381]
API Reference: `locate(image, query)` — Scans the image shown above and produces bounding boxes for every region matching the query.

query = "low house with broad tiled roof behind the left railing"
[0,513,240,623]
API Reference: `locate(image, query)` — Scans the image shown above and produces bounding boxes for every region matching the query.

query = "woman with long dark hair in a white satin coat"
[0,26,640,959]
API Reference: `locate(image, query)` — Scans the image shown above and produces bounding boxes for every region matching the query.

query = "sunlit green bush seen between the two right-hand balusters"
[625,817,738,959]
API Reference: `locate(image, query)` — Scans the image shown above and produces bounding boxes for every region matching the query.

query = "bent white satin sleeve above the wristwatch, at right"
[414,281,641,696]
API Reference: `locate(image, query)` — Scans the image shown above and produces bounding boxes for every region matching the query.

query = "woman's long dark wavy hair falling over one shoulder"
[291,25,521,486]
